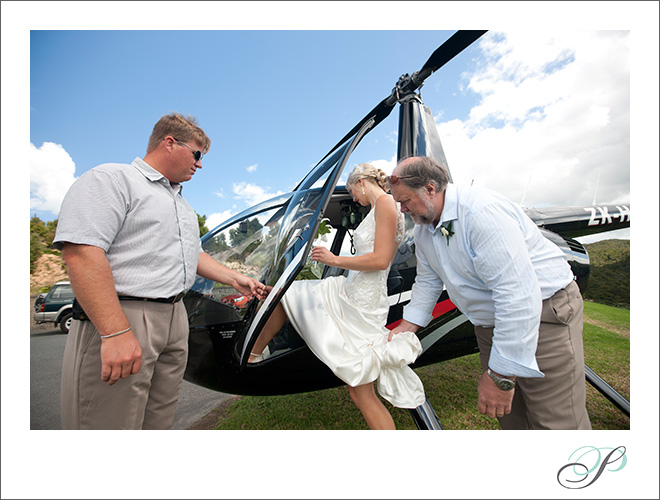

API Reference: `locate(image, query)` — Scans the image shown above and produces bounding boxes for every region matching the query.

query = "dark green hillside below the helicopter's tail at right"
[583,240,630,309]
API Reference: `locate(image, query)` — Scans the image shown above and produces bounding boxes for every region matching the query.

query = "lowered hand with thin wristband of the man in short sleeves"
[101,331,142,385]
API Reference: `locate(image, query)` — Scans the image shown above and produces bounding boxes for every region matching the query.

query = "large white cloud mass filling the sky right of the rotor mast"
[436,31,630,206]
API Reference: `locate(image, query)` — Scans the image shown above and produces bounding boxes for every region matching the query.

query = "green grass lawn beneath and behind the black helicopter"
[210,302,630,430]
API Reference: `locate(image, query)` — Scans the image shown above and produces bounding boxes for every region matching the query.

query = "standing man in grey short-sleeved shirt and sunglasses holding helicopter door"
[53,113,265,429]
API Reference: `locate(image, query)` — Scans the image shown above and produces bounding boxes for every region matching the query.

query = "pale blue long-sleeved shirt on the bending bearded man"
[403,184,573,377]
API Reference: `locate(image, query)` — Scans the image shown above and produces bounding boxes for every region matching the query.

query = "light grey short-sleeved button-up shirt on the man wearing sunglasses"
[53,158,202,298]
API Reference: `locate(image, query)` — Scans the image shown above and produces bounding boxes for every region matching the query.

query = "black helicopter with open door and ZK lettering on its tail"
[183,31,630,430]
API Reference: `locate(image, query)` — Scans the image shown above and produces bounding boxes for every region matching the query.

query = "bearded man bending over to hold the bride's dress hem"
[390,157,591,429]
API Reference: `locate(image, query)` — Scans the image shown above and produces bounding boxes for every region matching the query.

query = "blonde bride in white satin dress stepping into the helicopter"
[248,163,425,429]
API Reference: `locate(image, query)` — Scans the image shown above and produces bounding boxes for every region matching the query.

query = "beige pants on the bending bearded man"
[474,282,591,429]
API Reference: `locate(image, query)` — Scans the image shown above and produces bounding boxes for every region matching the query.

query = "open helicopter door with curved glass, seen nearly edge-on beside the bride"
[235,119,374,366]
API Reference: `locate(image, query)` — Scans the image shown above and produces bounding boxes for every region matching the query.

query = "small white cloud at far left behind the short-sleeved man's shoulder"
[30,142,76,215]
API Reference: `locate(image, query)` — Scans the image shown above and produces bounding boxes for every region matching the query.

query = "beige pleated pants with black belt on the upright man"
[61,301,188,429]
